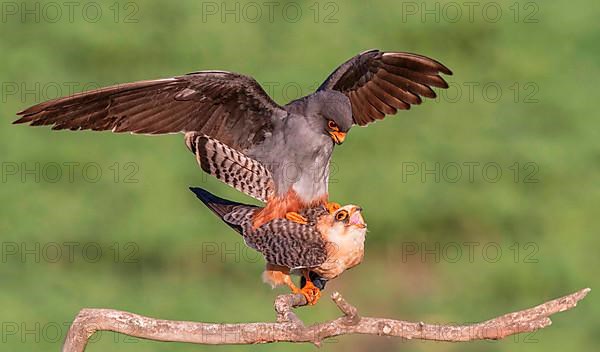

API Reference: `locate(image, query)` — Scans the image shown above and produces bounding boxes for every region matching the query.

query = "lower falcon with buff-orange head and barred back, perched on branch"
[190,187,367,305]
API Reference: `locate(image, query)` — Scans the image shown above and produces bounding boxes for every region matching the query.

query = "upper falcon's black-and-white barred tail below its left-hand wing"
[186,133,273,202]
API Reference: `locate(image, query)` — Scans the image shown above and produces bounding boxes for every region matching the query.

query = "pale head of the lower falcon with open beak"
[320,204,367,242]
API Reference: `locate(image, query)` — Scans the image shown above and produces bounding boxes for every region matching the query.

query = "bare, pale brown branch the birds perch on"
[62,288,590,352]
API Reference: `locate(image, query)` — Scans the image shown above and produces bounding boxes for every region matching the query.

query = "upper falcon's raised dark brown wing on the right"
[319,50,452,126]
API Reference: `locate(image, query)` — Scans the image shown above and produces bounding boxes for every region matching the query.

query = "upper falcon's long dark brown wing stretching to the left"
[14,71,285,150]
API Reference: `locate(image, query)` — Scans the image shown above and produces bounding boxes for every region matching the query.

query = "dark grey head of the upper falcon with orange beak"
[307,90,353,145]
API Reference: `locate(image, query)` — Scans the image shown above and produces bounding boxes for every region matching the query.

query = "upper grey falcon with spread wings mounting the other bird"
[14,50,452,228]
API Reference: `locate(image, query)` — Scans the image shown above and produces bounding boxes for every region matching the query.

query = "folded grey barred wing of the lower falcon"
[245,219,327,269]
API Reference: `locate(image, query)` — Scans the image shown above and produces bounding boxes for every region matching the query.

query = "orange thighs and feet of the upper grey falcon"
[252,189,329,229]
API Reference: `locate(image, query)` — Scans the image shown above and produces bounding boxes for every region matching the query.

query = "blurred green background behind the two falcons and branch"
[0,0,600,352]
